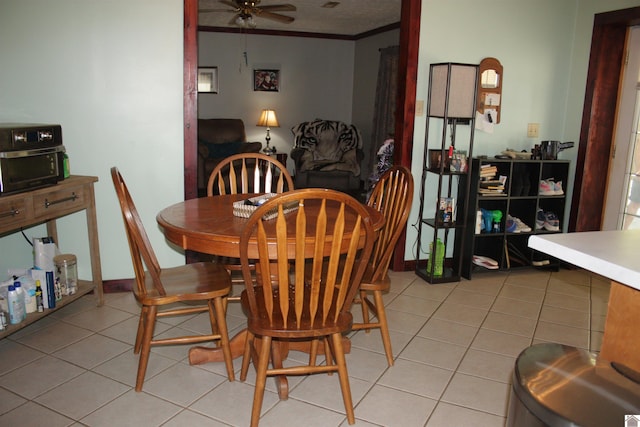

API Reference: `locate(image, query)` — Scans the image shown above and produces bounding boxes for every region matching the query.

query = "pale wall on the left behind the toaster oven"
[0,0,184,279]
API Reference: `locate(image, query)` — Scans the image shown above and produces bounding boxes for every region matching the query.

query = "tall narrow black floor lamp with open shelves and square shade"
[416,62,478,284]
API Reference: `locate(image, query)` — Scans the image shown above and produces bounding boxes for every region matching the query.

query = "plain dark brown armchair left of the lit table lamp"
[198,119,262,196]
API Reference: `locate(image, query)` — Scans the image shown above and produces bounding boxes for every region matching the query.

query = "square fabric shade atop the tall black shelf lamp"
[427,63,478,119]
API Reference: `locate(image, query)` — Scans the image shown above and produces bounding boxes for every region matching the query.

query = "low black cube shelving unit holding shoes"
[462,158,569,279]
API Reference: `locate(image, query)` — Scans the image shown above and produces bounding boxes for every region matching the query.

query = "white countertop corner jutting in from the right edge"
[529,230,640,290]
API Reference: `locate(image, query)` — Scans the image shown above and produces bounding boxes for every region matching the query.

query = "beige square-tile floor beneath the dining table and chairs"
[0,269,609,427]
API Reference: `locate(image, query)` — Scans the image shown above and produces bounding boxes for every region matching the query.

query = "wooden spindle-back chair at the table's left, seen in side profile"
[111,167,234,391]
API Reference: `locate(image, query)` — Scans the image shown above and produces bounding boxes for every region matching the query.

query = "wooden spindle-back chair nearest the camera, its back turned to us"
[240,189,376,426]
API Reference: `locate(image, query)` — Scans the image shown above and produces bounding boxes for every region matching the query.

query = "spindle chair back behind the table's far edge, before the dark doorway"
[207,153,293,196]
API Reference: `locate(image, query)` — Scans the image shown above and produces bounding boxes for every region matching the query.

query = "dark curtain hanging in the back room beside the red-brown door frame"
[368,46,400,189]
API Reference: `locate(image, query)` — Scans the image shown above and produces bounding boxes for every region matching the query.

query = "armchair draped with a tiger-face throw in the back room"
[291,119,364,196]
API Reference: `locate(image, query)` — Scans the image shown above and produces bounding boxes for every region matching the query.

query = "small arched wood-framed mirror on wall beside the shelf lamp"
[476,58,504,124]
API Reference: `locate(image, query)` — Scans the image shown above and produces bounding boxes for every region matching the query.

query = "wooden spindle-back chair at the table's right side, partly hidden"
[353,166,413,366]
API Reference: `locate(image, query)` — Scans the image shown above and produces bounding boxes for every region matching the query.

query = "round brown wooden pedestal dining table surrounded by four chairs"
[156,194,385,365]
